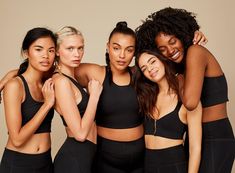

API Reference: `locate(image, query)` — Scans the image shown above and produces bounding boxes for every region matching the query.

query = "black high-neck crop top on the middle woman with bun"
[96,68,142,129]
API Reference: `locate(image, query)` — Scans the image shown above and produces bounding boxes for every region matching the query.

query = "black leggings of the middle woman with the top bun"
[93,136,145,173]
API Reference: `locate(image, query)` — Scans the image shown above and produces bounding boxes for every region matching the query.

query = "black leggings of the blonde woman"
[54,137,96,173]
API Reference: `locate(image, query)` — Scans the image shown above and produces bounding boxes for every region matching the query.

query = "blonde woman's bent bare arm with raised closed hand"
[55,76,102,141]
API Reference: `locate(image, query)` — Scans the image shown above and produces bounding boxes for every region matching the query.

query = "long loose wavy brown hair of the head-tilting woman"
[134,49,179,117]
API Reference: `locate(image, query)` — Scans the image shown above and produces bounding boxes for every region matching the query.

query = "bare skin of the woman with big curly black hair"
[155,33,227,122]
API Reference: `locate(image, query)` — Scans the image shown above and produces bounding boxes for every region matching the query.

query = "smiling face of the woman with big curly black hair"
[155,32,184,63]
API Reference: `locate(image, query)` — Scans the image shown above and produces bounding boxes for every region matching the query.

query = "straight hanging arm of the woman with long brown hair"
[187,103,202,173]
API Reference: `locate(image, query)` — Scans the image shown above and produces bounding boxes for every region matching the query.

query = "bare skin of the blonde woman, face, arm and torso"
[53,30,102,143]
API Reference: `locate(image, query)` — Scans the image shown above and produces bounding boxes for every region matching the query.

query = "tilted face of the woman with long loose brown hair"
[138,53,165,83]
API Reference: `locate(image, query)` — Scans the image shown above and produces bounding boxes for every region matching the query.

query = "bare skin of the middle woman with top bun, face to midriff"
[76,33,143,141]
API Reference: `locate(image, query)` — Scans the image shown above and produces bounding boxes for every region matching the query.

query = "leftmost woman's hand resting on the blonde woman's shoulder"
[42,78,55,107]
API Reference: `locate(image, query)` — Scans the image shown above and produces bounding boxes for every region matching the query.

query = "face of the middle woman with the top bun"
[107,33,135,70]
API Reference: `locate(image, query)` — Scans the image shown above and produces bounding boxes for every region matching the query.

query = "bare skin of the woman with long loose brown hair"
[138,53,202,173]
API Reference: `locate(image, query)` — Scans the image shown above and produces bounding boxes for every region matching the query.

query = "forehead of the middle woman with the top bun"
[110,33,135,46]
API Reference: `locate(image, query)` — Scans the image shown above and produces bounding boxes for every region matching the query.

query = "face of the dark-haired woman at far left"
[24,37,55,72]
